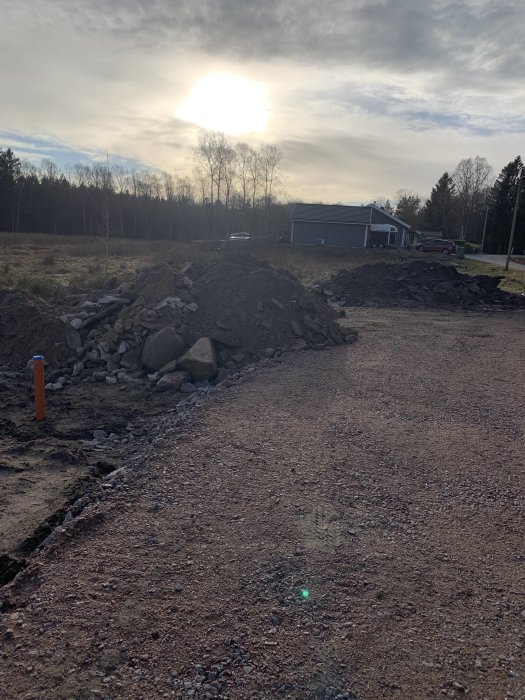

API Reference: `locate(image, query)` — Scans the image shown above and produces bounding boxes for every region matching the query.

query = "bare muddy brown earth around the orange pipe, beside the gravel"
[0,373,190,585]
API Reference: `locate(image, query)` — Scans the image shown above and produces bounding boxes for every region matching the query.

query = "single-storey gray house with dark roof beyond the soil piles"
[291,204,417,248]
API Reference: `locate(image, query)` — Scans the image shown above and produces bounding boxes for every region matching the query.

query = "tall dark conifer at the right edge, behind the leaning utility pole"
[485,156,525,255]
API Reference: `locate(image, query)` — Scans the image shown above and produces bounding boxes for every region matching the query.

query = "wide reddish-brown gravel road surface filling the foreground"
[0,309,525,700]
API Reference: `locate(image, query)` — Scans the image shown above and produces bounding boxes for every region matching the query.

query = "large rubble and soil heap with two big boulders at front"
[5,256,344,393]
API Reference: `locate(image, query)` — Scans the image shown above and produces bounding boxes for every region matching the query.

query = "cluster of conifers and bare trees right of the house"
[382,156,525,254]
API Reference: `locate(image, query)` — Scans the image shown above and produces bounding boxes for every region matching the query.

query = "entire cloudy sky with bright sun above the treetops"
[0,0,525,204]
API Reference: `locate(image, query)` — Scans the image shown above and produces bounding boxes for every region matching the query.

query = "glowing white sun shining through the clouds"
[176,73,268,135]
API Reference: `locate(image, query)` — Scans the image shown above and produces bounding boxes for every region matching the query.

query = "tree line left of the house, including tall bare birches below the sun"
[0,133,289,241]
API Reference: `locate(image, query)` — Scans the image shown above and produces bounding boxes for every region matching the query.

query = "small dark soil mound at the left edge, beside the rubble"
[0,289,67,367]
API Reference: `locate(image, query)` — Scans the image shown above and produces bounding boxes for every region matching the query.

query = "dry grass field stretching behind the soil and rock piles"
[0,233,525,297]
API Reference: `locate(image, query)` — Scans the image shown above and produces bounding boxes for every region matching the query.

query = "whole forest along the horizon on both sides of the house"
[0,132,525,253]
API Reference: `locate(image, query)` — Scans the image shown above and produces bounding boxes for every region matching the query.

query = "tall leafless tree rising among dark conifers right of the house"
[452,156,493,239]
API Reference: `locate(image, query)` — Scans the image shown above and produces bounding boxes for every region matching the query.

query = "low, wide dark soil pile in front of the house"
[315,260,525,308]
